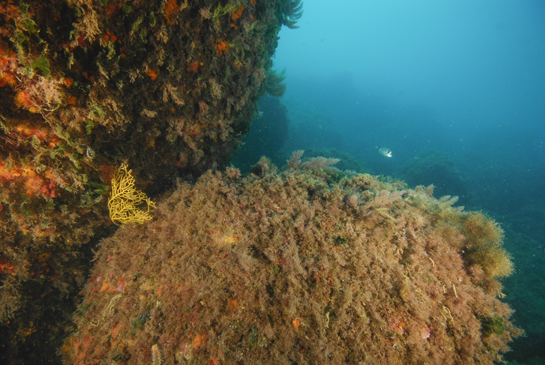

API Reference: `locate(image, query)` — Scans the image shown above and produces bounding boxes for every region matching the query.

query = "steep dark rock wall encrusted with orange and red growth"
[0,0,293,358]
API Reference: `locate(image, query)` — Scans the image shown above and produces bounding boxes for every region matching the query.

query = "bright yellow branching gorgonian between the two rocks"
[108,163,155,224]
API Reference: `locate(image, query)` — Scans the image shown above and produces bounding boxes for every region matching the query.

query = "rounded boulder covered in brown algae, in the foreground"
[63,154,521,364]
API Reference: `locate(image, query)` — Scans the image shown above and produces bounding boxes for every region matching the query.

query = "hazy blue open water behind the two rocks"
[266,0,545,363]
